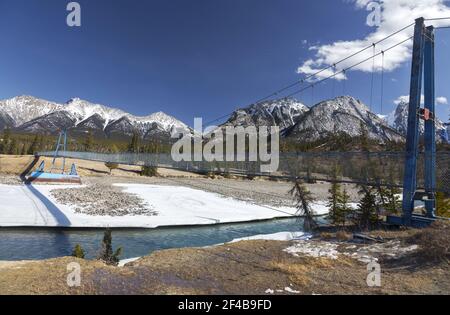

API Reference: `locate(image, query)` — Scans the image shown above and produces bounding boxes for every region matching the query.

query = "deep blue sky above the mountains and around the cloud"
[0,0,450,125]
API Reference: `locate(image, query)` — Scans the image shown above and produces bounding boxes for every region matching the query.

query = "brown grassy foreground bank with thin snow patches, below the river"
[0,226,450,294]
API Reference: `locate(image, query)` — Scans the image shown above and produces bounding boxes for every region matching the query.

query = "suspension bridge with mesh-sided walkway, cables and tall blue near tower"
[36,17,450,225]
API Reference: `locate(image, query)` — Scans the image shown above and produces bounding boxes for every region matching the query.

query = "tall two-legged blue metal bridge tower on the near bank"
[400,18,436,226]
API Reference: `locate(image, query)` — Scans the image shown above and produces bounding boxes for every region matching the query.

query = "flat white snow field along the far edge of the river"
[0,184,327,228]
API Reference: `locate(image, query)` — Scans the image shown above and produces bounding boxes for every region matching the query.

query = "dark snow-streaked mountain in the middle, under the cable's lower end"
[222,98,308,130]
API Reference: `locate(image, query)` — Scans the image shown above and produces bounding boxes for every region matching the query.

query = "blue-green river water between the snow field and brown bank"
[0,218,324,260]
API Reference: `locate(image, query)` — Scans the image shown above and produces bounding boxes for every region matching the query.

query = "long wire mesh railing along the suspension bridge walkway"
[38,151,450,193]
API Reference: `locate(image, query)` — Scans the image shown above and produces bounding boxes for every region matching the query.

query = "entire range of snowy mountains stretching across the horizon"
[0,96,449,143]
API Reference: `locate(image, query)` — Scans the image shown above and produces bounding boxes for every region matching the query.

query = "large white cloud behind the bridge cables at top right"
[297,0,450,80]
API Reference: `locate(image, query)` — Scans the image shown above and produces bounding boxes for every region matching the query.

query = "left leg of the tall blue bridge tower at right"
[402,18,425,225]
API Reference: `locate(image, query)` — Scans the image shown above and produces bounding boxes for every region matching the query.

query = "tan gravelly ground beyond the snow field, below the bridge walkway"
[0,155,359,207]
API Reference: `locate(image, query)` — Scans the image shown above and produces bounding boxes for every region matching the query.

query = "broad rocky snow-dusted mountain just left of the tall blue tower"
[284,96,404,142]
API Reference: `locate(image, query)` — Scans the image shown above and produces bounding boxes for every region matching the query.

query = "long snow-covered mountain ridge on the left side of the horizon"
[0,96,189,137]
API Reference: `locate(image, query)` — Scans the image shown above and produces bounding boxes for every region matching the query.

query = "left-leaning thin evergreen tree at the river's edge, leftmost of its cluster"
[290,181,317,232]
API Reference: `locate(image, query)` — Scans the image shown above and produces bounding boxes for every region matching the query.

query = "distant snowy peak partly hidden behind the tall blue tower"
[382,101,449,141]
